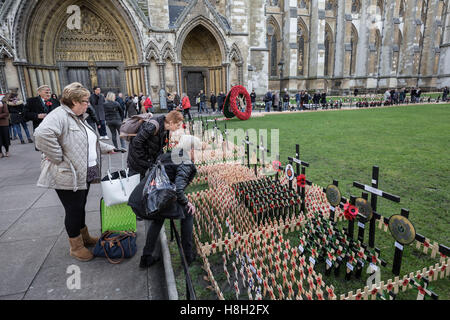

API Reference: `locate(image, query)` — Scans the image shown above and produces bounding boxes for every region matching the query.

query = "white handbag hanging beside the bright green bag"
[101,153,141,207]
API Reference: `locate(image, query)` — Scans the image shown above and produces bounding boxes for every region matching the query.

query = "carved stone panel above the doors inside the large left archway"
[56,8,124,61]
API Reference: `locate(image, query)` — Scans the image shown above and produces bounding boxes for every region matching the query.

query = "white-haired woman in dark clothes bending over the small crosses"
[139,135,202,268]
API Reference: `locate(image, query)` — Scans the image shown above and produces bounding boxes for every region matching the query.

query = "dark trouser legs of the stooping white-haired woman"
[143,211,194,261]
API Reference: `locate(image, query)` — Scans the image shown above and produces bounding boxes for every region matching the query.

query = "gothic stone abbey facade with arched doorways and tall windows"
[0,0,450,105]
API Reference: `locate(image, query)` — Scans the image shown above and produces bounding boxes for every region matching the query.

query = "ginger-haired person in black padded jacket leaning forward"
[127,110,183,178]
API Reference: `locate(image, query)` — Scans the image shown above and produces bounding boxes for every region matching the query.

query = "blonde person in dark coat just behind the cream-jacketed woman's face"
[103,92,127,152]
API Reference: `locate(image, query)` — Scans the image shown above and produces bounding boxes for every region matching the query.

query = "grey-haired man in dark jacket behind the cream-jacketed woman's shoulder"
[25,85,52,130]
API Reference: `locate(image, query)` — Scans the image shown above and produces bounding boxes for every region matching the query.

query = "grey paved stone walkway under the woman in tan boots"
[0,122,168,300]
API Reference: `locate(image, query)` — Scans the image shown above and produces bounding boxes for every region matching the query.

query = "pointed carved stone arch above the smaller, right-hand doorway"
[175,15,229,63]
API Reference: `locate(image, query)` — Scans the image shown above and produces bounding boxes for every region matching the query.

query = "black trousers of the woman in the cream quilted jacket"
[56,183,90,238]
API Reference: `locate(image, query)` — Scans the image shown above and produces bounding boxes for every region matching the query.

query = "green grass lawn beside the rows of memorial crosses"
[168,104,450,299]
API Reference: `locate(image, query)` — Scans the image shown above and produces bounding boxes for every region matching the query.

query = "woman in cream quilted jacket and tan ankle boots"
[34,82,114,261]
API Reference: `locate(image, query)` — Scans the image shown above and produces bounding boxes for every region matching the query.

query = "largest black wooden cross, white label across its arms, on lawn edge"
[353,166,400,248]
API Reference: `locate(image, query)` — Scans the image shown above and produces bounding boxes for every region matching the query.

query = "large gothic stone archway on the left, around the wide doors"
[17,0,145,96]
